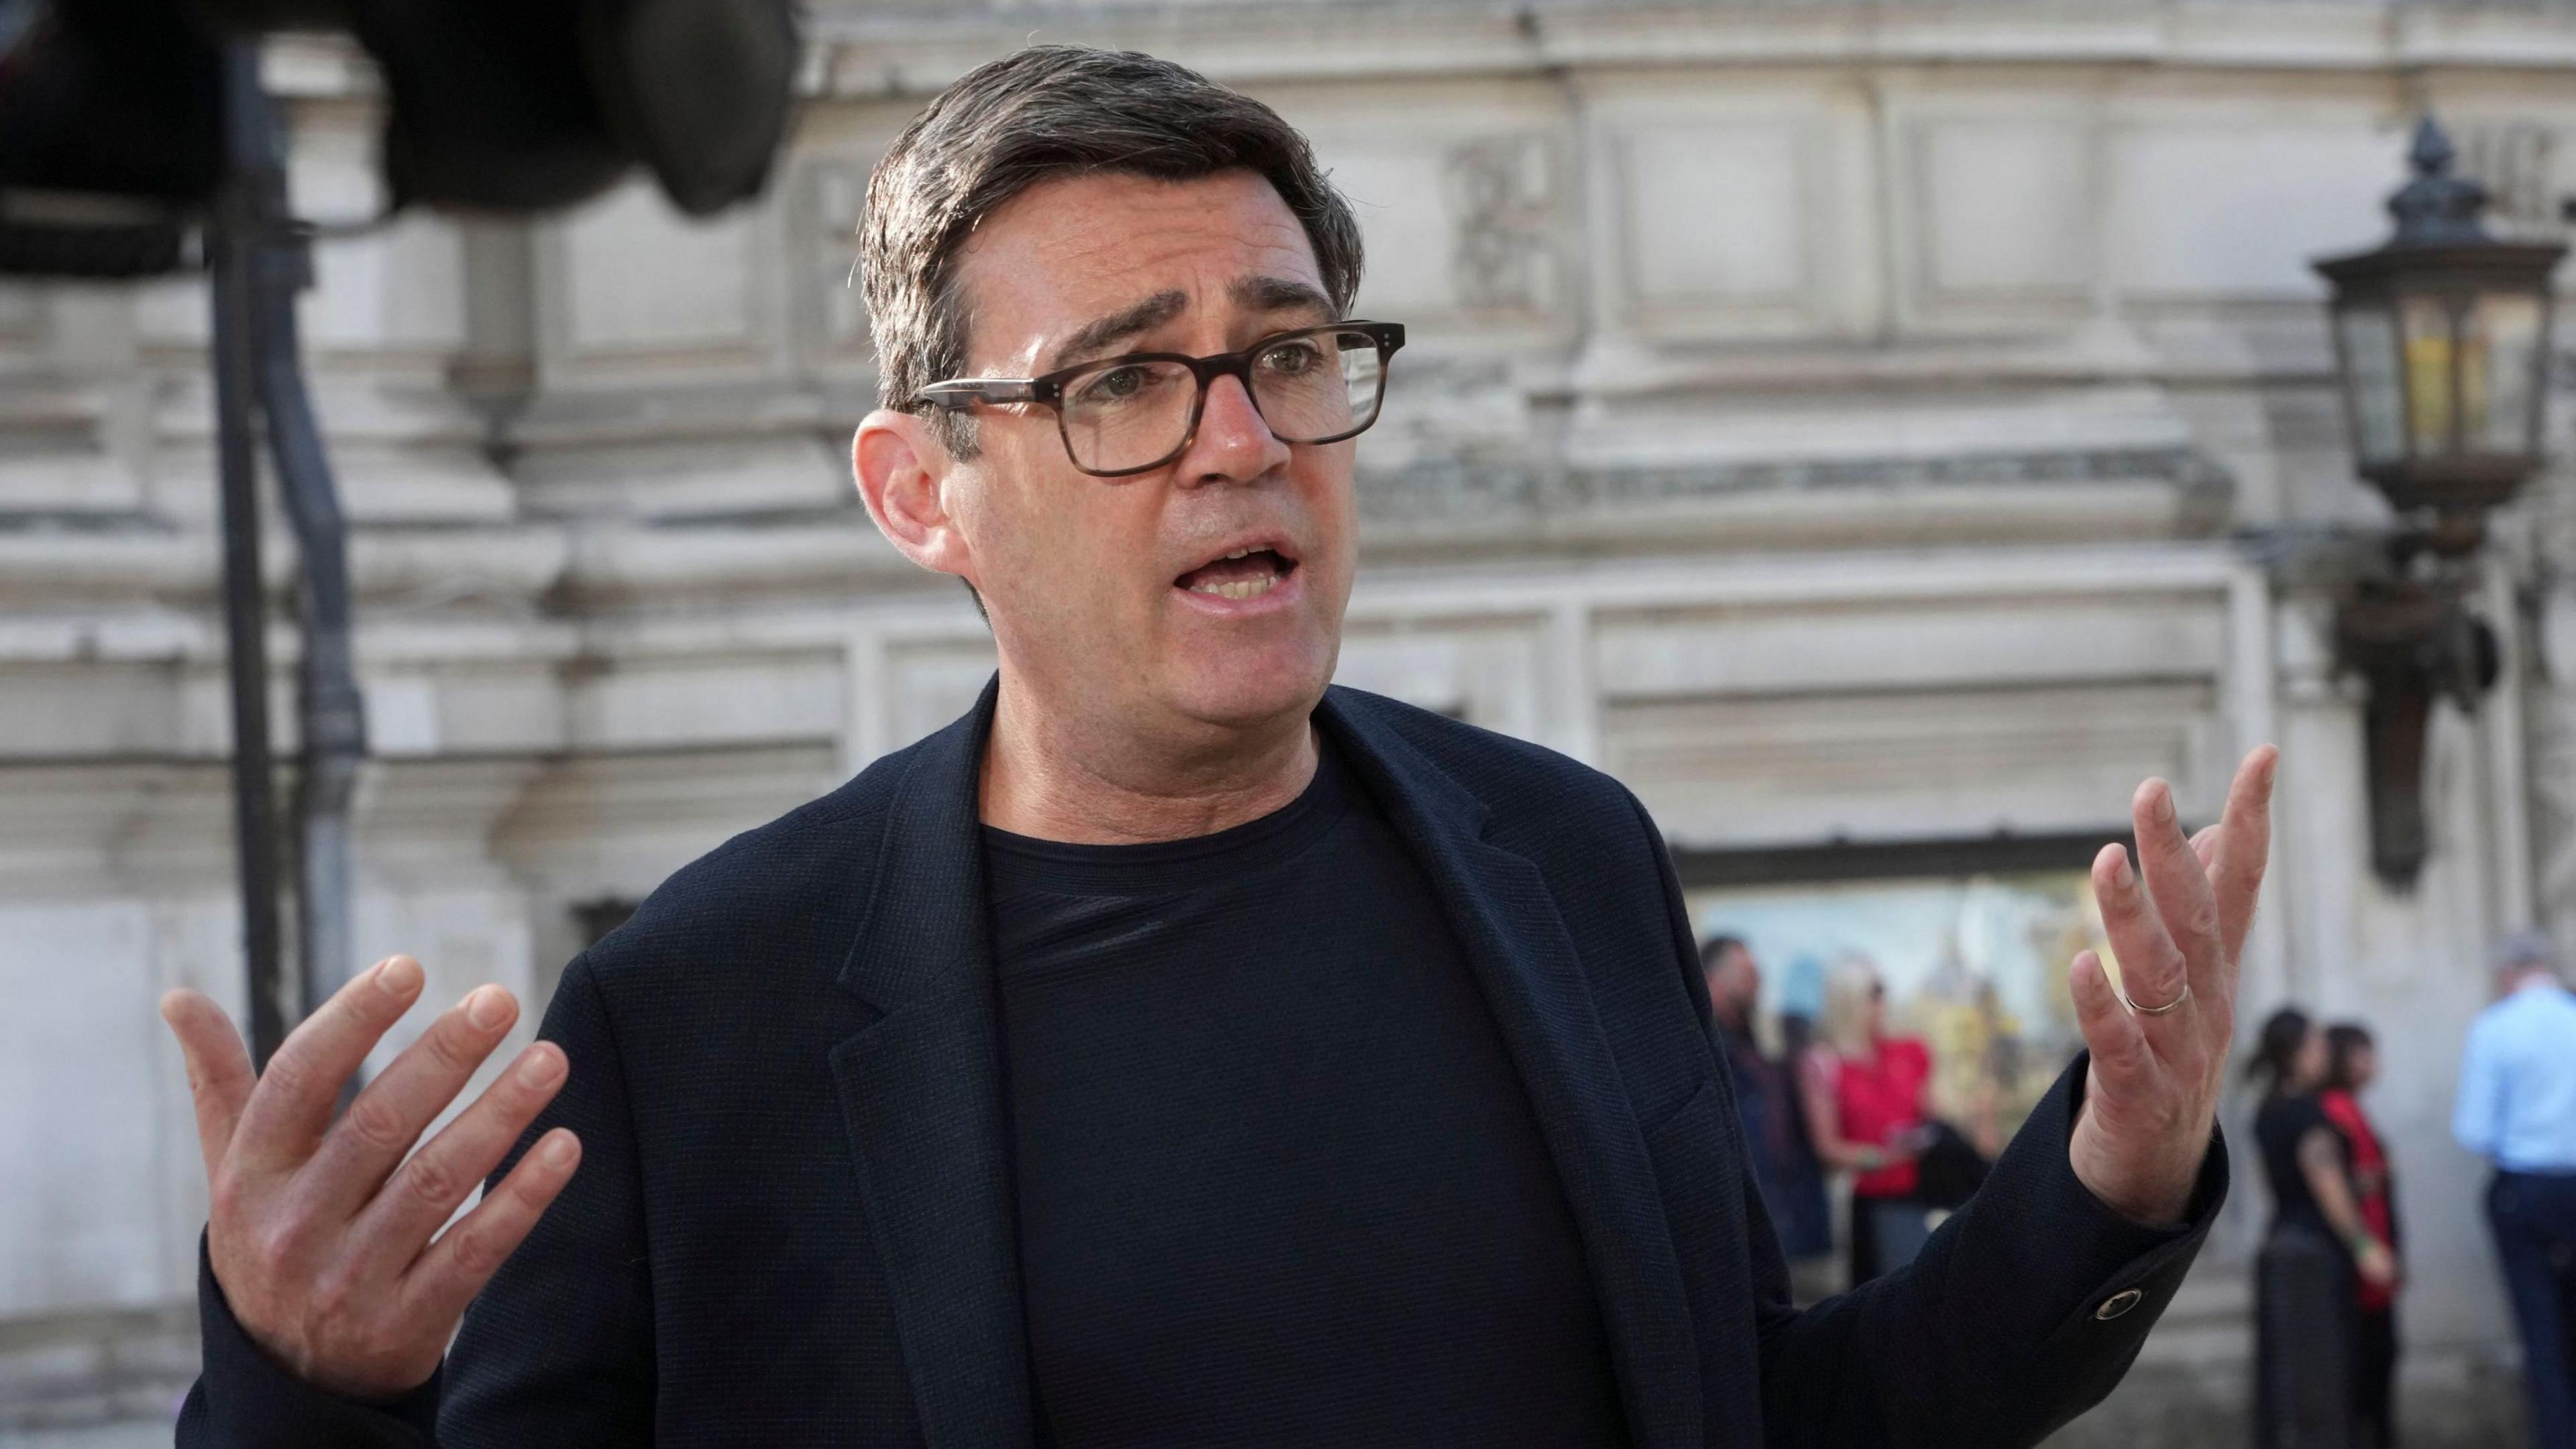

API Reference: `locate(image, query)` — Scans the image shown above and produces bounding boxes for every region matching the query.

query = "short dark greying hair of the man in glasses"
[858,46,1360,459]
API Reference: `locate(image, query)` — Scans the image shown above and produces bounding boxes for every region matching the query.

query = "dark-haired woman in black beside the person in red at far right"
[2246,1006,2398,1449]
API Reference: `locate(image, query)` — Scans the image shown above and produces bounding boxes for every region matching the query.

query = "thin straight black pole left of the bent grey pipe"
[209,41,288,1067]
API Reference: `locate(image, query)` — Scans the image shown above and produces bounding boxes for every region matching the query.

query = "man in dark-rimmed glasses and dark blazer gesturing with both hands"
[165,46,2272,1449]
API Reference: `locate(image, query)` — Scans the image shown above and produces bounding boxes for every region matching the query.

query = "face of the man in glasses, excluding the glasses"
[948,170,1355,740]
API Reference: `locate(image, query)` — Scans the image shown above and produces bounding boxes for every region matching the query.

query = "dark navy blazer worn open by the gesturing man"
[178,686,2226,1449]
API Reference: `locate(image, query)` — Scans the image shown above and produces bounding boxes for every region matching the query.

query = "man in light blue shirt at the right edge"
[2450,933,2576,1449]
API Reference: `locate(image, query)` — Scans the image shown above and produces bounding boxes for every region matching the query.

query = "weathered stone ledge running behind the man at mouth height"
[0,449,2231,619]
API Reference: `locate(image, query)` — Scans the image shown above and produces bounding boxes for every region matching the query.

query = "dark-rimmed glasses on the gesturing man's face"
[912,322,1404,477]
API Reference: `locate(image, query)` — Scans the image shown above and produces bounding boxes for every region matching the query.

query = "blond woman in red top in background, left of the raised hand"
[1798,959,1932,1287]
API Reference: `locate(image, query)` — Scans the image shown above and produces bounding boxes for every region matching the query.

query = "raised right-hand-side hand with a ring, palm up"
[2066,745,2279,1225]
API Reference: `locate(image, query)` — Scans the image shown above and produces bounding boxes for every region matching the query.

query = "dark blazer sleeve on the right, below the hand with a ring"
[1638,789,2229,1449]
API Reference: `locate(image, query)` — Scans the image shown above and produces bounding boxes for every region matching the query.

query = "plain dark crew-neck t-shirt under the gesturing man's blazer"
[984,750,1623,1449]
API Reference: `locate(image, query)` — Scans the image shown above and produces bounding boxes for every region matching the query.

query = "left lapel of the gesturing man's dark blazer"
[832,684,1033,1449]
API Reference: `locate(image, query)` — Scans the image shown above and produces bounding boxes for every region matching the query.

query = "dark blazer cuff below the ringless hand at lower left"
[178,1232,445,1449]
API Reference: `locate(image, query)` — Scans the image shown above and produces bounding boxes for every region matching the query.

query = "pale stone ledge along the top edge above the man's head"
[812,0,2576,98]
